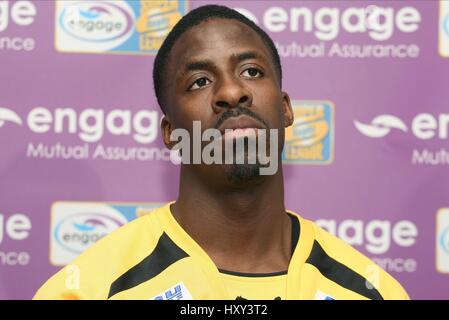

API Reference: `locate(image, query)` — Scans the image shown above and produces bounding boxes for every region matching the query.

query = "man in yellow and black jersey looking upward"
[35,6,408,300]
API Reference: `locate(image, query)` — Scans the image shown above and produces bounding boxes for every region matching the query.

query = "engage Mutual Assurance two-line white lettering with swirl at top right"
[236,1,421,60]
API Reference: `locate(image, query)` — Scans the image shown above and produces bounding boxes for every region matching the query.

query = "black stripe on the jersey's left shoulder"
[108,232,189,299]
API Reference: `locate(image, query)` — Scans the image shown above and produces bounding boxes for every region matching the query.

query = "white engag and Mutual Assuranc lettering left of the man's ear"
[0,107,170,161]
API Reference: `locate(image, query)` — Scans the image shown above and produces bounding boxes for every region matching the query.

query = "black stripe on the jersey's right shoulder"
[306,240,383,300]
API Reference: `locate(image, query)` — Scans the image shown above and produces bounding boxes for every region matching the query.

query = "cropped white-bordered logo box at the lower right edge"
[436,208,449,273]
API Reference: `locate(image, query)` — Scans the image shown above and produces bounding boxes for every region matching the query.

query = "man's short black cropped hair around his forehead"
[153,5,282,113]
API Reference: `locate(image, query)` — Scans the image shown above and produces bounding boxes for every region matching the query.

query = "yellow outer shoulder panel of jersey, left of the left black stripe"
[35,208,170,299]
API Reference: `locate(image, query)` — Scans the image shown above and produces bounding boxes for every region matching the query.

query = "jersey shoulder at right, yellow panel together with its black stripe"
[288,215,408,299]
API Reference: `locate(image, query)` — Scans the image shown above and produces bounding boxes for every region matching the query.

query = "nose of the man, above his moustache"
[212,76,253,113]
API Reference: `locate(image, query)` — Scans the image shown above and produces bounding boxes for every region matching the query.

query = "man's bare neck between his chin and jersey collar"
[172,168,291,273]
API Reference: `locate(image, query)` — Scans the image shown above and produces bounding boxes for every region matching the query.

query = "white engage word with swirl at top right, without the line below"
[235,2,421,41]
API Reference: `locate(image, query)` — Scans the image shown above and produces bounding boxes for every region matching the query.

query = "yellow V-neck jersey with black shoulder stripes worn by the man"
[34,203,408,300]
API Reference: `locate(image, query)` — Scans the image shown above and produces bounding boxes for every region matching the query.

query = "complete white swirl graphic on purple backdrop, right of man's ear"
[354,114,407,138]
